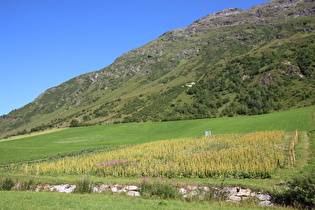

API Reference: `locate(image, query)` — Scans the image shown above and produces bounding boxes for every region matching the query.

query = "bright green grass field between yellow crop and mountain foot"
[0,107,314,165]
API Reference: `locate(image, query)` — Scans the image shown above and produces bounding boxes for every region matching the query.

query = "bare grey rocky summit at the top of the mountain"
[173,0,315,37]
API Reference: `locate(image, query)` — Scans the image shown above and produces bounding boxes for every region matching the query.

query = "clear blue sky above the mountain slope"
[0,0,267,115]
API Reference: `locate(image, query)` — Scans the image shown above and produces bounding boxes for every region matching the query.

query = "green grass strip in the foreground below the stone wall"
[0,191,283,210]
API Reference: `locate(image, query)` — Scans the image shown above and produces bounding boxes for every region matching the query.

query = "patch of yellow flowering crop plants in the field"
[21,131,284,178]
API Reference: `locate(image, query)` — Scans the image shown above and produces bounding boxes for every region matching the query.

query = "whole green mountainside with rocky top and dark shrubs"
[0,0,315,137]
